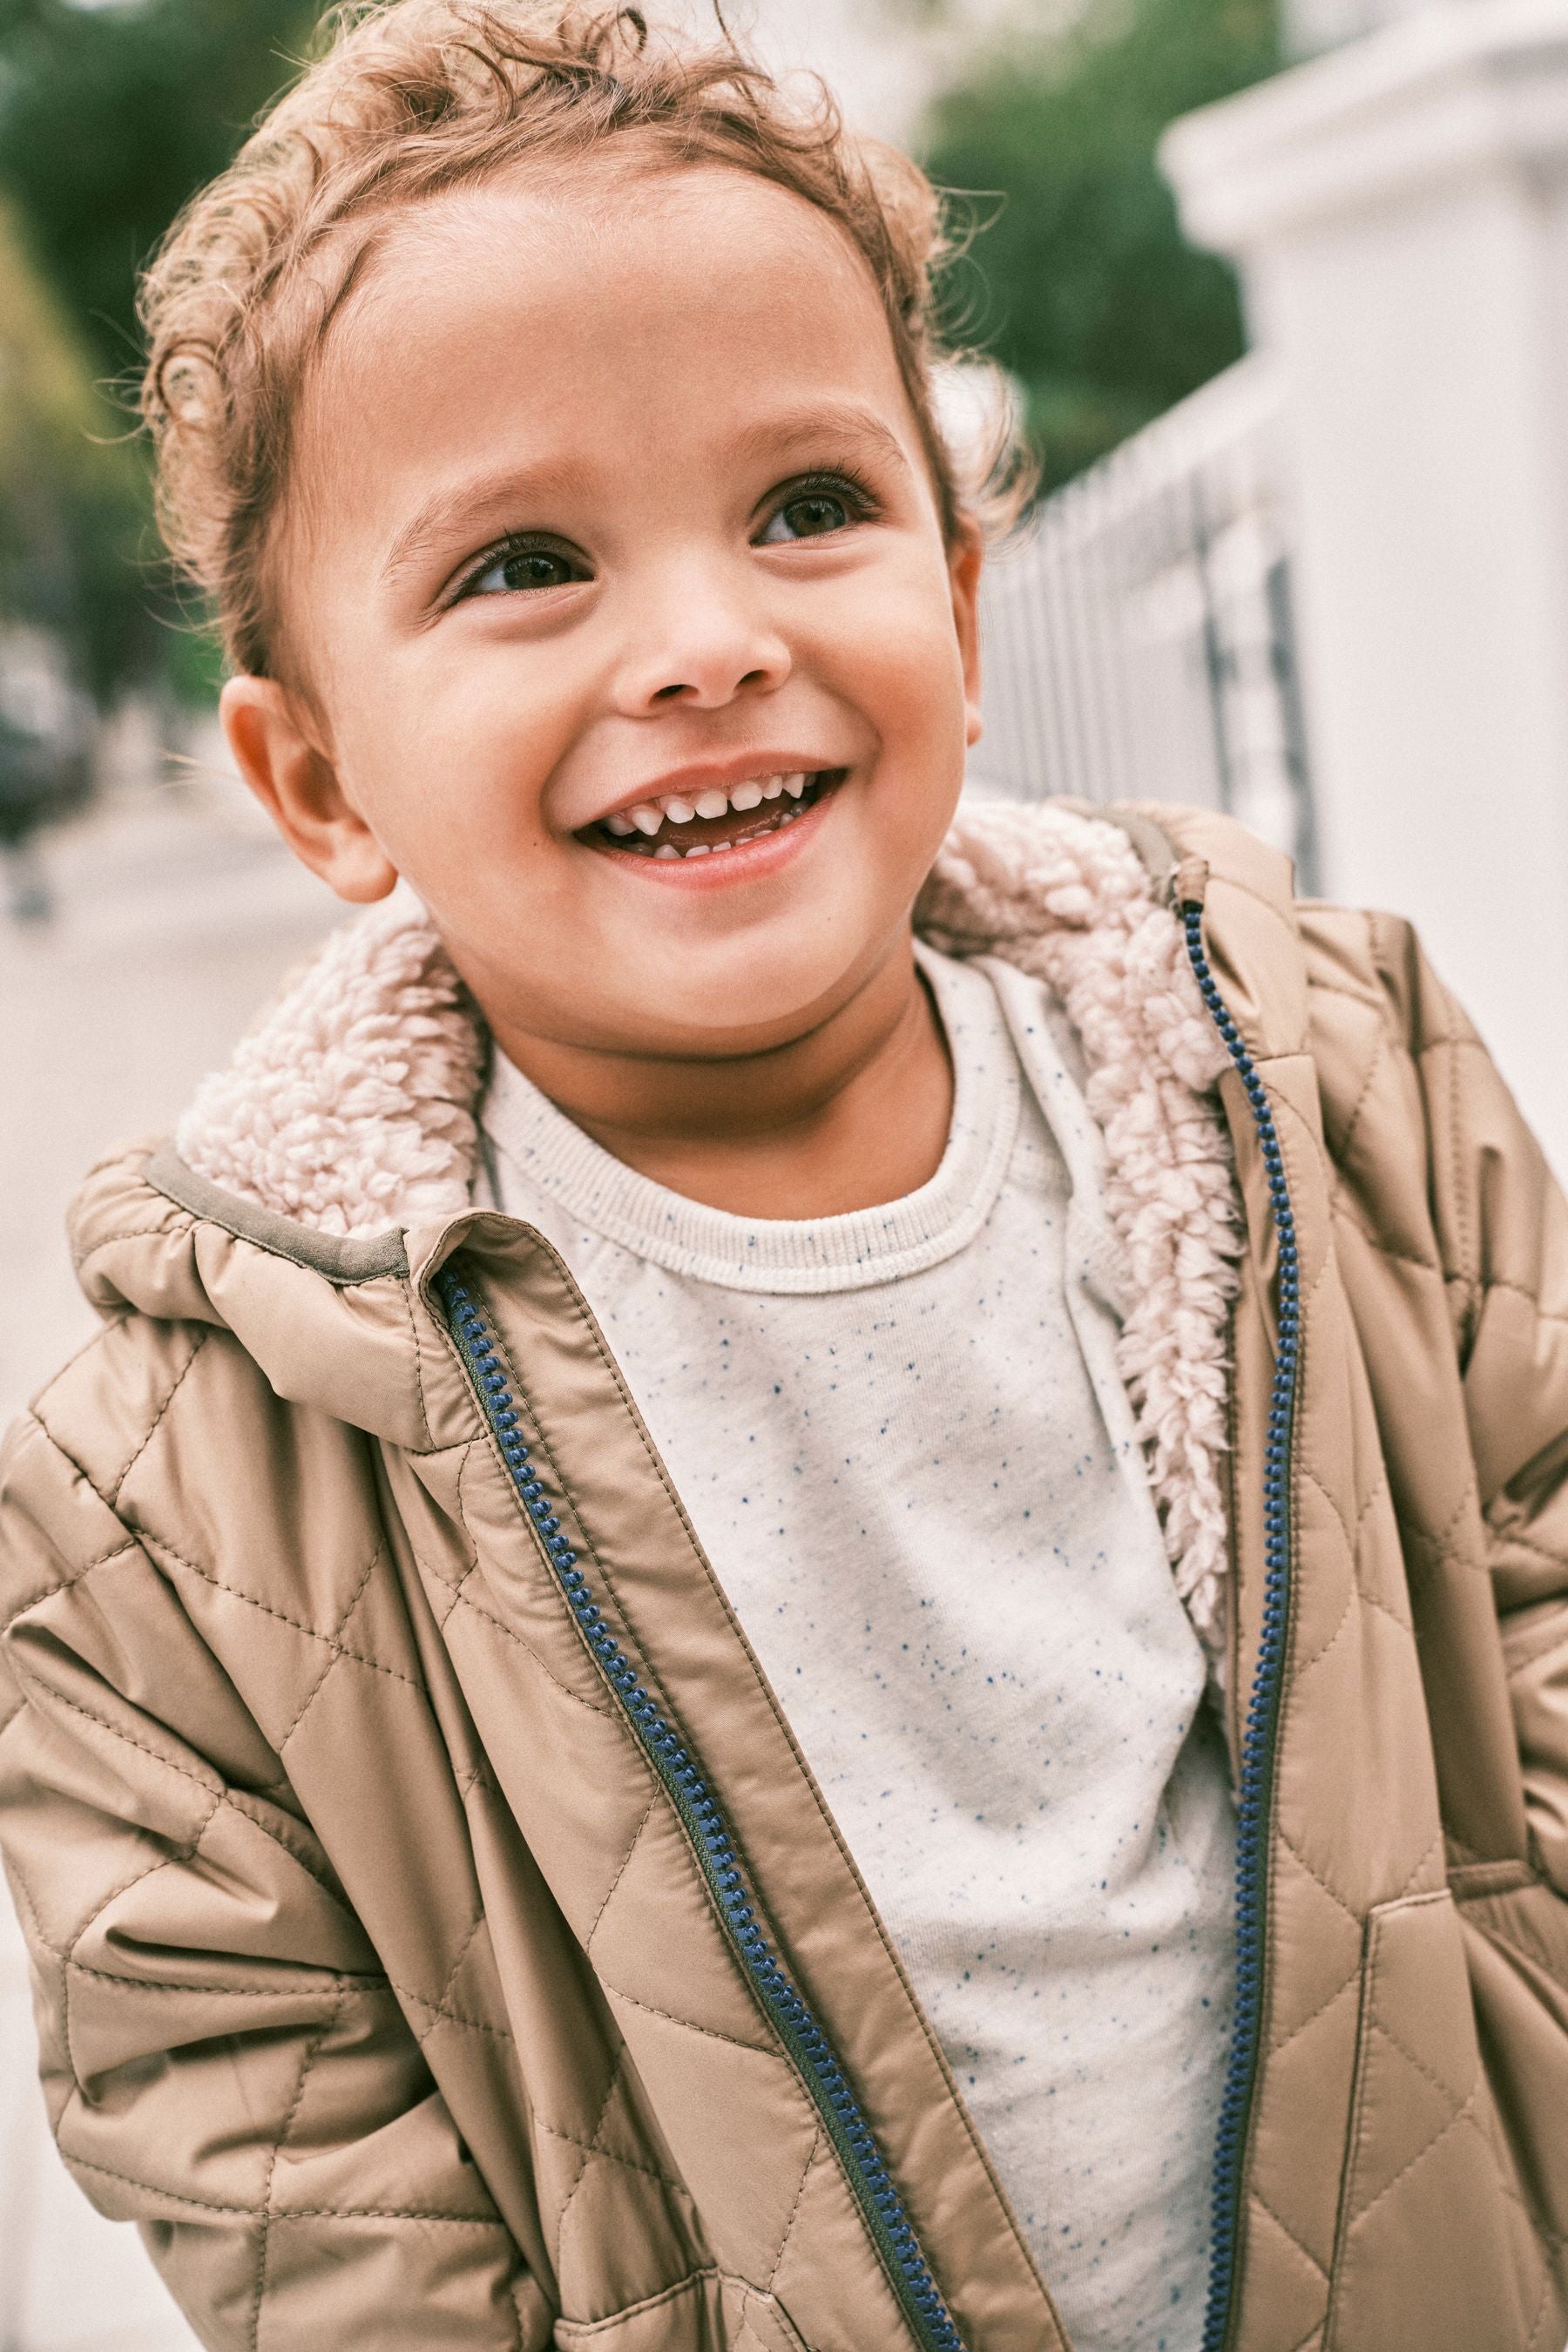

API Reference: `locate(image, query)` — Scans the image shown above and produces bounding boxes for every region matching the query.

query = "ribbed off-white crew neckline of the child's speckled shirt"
[482,941,1023,1291]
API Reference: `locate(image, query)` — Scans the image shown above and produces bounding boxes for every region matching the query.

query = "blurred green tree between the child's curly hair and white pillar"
[924,0,1283,487]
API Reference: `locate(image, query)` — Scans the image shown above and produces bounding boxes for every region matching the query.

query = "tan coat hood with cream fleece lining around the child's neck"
[71,802,1260,1656]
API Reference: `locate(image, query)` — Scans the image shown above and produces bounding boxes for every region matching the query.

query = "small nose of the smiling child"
[616,567,790,718]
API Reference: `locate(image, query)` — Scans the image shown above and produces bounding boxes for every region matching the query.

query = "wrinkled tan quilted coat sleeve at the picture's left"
[0,1421,552,2352]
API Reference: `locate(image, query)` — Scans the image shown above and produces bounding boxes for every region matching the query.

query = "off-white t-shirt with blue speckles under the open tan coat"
[484,950,1234,2352]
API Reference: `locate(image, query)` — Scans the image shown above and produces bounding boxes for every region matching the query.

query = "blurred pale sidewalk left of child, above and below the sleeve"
[0,760,343,2352]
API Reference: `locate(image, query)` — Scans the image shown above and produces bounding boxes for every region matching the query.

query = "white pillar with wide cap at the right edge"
[1164,0,1568,1176]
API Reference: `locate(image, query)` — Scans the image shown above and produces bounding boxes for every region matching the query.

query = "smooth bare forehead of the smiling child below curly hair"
[301,165,919,504]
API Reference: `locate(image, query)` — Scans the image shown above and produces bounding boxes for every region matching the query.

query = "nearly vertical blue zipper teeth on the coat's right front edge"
[1182,901,1300,2352]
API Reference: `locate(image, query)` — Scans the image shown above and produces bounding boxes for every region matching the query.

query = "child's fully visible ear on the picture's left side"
[219,678,397,906]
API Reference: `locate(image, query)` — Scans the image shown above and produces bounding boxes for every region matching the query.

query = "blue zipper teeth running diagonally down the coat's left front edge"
[435,1270,963,2352]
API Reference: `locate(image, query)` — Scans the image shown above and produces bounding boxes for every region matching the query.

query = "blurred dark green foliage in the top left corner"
[0,0,317,701]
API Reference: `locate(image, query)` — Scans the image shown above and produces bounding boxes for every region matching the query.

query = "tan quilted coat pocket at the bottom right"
[1323,1889,1540,2352]
